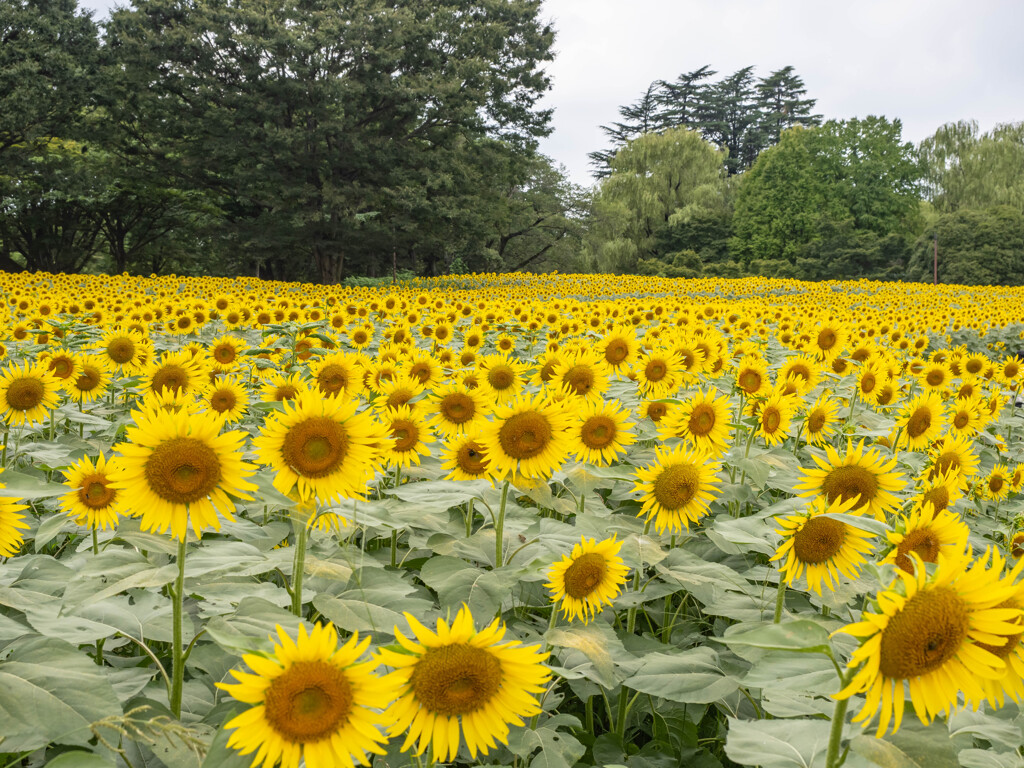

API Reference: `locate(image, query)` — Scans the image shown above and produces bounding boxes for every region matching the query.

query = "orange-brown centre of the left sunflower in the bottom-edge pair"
[263,662,352,743]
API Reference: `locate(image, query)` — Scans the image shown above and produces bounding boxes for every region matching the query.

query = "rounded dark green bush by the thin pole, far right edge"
[907,206,1024,286]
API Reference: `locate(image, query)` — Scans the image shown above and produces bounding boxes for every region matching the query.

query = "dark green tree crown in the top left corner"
[0,0,99,154]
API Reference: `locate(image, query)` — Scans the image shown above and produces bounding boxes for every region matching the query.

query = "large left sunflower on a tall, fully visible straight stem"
[112,410,256,541]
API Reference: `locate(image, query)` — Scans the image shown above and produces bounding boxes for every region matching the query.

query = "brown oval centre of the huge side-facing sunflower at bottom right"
[879,587,969,680]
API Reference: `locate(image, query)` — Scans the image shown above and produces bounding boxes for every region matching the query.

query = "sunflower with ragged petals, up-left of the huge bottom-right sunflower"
[771,496,874,595]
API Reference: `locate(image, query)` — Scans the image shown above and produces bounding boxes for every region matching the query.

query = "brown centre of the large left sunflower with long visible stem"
[144,437,220,504]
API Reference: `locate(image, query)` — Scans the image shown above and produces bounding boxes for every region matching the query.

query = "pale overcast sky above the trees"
[79,0,1024,183]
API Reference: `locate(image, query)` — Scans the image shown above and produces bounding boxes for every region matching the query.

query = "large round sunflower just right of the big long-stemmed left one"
[253,390,391,503]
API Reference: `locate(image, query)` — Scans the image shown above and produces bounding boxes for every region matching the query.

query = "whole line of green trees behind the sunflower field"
[6,0,1024,285]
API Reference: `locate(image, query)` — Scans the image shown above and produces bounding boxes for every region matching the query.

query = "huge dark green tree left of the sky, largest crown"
[106,0,553,283]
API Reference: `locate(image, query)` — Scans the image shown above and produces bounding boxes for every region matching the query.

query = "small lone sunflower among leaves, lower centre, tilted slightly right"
[544,537,630,624]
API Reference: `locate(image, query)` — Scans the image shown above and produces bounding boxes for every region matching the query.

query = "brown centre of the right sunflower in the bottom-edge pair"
[410,643,502,717]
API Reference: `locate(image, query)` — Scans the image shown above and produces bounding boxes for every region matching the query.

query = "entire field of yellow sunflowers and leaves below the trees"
[0,273,1024,768]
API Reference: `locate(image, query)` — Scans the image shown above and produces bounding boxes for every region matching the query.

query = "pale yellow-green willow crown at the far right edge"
[920,120,1024,213]
